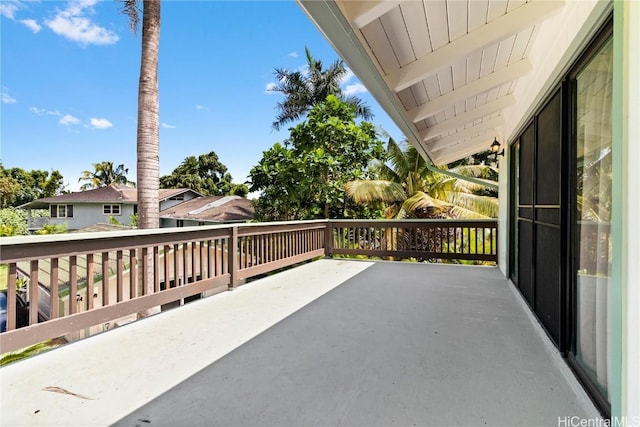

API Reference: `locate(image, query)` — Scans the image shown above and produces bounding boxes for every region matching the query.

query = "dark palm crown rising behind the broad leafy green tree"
[270,47,373,130]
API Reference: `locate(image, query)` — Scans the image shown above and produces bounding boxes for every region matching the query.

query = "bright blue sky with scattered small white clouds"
[0,0,402,191]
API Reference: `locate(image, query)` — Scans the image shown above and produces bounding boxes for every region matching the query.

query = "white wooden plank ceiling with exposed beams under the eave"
[301,0,563,165]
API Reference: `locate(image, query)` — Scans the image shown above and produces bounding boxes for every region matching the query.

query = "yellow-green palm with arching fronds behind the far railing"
[345,138,498,218]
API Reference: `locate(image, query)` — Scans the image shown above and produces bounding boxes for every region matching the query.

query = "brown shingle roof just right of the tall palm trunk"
[160,196,254,222]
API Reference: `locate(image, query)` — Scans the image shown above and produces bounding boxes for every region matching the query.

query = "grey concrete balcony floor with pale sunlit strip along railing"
[0,260,599,427]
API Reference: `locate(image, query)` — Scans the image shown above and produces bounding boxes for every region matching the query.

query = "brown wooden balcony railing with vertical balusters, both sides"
[0,220,497,353]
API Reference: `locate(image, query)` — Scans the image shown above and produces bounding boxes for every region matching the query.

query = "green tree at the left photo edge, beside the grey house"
[0,162,65,207]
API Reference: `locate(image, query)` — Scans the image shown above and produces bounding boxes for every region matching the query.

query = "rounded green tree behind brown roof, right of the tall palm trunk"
[160,151,248,196]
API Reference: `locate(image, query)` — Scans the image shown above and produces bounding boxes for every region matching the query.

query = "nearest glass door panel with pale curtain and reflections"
[572,38,613,400]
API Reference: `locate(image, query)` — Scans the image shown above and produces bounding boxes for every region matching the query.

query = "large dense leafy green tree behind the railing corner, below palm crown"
[249,95,384,221]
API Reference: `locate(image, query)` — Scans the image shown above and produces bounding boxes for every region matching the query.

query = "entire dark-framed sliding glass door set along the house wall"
[509,20,613,414]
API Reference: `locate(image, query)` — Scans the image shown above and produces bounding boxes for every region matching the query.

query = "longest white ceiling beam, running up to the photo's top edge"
[386,1,564,92]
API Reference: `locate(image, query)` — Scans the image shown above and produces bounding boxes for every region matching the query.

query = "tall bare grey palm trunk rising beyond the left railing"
[137,0,160,317]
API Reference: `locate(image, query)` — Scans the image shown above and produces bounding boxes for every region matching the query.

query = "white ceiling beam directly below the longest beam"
[407,59,533,123]
